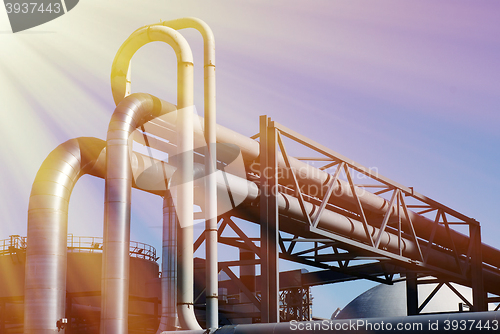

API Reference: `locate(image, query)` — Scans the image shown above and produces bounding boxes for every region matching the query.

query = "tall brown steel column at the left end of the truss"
[260,116,279,323]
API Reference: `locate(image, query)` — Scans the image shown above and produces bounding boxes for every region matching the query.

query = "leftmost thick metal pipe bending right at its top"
[24,138,105,334]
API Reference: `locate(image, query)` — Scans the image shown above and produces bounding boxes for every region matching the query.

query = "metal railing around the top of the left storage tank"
[0,234,158,262]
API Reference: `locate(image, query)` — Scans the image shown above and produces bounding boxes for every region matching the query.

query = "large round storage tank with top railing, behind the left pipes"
[0,235,161,334]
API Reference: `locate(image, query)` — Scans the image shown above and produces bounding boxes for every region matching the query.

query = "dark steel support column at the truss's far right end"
[469,222,488,312]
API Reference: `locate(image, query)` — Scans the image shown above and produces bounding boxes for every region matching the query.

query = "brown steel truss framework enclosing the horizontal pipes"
[188,116,499,322]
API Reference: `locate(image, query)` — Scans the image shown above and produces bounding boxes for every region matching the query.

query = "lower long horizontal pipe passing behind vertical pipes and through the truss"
[75,138,500,293]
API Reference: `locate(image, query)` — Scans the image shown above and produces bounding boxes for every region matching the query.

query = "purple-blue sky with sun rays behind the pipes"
[0,0,500,317]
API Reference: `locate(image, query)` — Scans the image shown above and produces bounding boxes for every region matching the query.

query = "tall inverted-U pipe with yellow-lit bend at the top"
[109,25,197,334]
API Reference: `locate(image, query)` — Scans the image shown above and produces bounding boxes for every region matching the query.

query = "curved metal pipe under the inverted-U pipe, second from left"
[101,94,180,334]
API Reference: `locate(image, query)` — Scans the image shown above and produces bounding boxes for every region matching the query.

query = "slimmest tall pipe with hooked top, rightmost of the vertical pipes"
[157,17,219,329]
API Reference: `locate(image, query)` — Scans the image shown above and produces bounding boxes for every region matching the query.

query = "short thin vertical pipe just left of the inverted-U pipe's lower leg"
[157,191,178,334]
